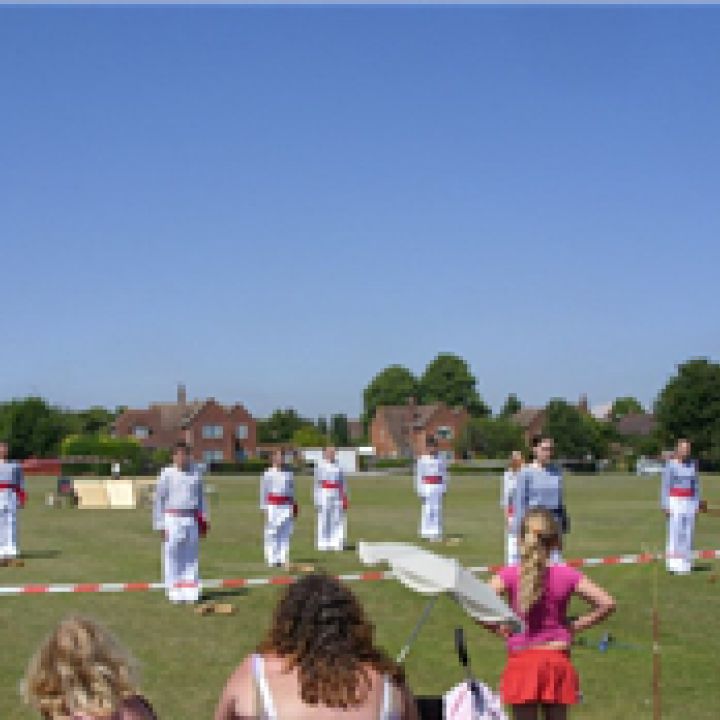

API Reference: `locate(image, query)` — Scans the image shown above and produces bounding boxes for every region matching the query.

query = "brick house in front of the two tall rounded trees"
[370,401,470,459]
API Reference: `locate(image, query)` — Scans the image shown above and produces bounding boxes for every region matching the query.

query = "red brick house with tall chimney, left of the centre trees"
[113,385,257,463]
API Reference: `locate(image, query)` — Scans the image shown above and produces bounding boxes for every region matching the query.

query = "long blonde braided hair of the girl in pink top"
[519,508,560,613]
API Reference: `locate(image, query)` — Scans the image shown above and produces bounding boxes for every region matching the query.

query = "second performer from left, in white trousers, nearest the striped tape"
[153,442,208,603]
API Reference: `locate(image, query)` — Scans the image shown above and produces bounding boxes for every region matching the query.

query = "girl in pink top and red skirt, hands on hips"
[483,508,615,720]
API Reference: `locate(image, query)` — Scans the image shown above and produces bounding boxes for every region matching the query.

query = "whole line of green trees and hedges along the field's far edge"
[0,353,720,467]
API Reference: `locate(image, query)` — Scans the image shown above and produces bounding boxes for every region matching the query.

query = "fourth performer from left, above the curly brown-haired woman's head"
[314,447,348,552]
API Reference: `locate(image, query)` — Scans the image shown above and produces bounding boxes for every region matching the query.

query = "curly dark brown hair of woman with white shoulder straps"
[258,573,402,708]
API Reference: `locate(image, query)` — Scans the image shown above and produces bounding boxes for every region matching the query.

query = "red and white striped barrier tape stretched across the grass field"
[0,550,720,595]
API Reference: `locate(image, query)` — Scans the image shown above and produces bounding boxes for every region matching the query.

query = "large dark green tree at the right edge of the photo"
[655,358,720,464]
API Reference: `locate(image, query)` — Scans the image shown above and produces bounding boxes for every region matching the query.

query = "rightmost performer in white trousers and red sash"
[661,439,700,574]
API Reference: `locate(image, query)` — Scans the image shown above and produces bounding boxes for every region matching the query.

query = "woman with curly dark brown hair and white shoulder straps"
[215,573,417,720]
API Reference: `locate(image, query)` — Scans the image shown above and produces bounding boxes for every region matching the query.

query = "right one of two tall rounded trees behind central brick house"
[419,353,490,417]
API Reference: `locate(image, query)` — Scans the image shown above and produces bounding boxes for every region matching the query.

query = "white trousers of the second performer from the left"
[162,515,200,602]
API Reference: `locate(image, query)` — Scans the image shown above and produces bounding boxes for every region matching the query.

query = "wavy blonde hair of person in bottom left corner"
[23,616,136,720]
